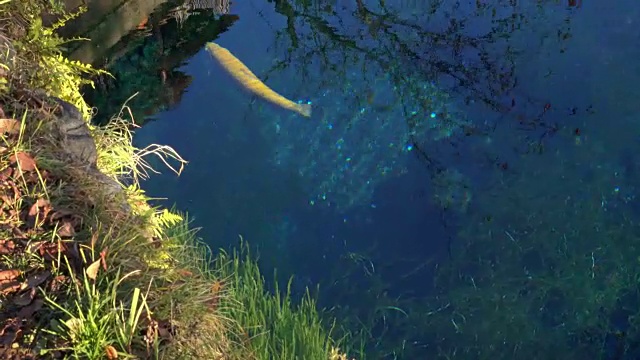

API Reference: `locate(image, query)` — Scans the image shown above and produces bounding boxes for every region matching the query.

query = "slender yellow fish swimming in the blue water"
[207,42,311,117]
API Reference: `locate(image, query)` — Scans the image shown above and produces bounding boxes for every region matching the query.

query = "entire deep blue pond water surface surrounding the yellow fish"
[72,0,640,359]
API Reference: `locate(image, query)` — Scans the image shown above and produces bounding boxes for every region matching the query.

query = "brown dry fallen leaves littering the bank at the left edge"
[0,148,85,359]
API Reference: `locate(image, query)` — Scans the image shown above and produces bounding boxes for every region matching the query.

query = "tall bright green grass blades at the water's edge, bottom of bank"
[215,238,356,360]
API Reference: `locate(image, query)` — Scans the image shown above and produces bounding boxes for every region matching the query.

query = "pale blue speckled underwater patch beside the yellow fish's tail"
[259,54,469,212]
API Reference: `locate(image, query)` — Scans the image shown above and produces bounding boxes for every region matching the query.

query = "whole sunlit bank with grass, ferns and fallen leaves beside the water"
[0,0,346,360]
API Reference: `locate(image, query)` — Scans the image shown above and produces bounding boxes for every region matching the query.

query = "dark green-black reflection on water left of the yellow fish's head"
[82,3,238,124]
